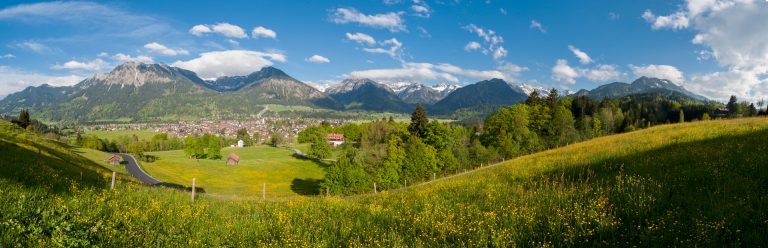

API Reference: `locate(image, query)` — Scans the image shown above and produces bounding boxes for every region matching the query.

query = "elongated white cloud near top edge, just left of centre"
[331,8,407,32]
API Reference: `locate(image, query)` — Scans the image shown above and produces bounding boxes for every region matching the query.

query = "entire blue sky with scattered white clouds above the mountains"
[0,0,768,101]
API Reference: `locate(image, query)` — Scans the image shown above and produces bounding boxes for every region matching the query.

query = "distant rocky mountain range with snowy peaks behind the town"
[0,62,703,122]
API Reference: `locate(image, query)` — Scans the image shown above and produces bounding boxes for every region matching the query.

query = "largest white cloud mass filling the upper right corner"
[643,0,768,100]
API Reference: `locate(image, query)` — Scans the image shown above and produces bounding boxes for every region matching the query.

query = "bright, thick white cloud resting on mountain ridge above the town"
[171,50,286,78]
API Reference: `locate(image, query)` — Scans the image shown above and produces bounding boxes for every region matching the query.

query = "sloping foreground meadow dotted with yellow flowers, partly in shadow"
[0,119,768,247]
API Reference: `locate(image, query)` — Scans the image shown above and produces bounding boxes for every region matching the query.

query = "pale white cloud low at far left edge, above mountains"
[0,66,85,95]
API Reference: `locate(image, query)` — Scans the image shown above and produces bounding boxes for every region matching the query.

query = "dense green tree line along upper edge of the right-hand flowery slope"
[298,89,765,195]
